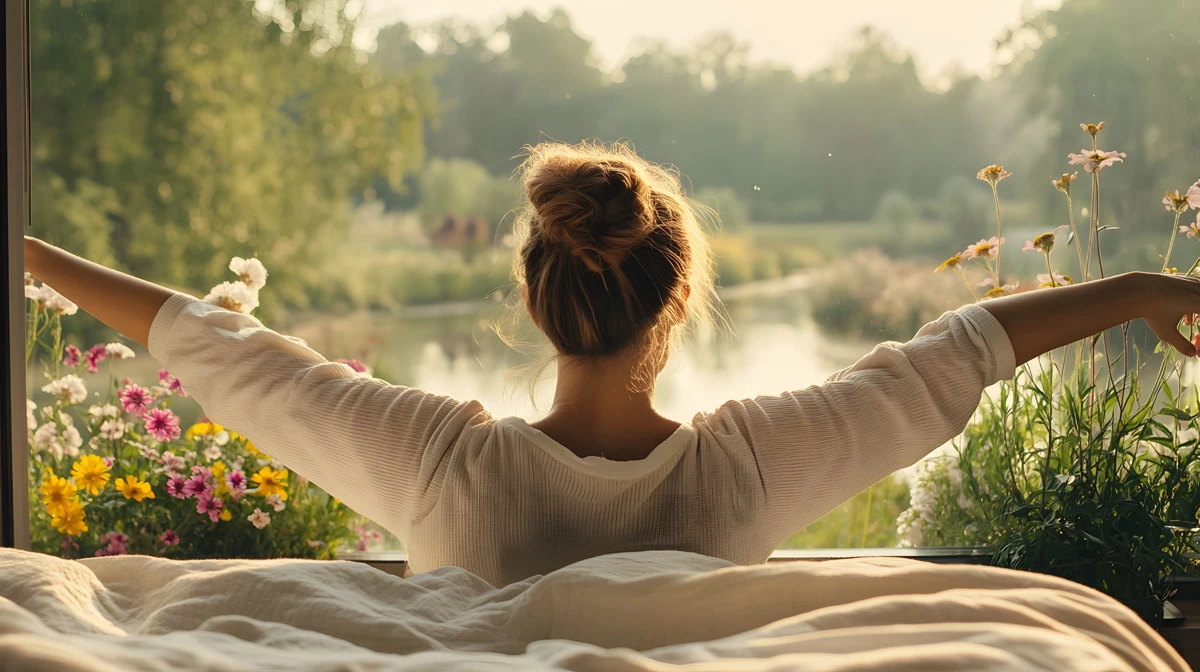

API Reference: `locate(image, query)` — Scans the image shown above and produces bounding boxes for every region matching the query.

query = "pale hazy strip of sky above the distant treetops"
[364,0,1060,76]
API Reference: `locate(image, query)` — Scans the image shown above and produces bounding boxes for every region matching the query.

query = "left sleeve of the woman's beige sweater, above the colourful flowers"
[149,294,485,533]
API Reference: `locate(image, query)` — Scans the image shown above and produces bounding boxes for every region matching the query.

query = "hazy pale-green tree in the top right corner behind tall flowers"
[1001,0,1200,248]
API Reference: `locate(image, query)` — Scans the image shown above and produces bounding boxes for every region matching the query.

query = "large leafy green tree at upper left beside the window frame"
[30,0,431,302]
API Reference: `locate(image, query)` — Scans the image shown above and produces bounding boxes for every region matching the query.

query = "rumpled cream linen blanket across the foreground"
[0,550,1188,672]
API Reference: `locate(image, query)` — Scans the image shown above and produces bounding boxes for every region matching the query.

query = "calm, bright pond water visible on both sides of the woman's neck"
[276,278,874,421]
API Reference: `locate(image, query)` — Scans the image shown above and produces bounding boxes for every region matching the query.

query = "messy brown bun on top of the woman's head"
[524,155,655,272]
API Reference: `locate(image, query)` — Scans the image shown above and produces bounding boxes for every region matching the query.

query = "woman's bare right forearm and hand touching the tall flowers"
[979,272,1200,365]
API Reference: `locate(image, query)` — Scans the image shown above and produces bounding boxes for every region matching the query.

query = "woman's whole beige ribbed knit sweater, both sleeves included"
[149,294,1015,584]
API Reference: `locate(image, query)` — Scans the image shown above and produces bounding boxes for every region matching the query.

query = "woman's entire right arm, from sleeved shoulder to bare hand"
[695,266,1200,541]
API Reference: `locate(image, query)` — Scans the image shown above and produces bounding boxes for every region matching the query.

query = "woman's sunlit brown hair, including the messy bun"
[514,143,713,383]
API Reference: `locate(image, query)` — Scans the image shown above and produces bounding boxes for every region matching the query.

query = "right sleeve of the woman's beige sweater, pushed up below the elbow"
[697,305,1016,541]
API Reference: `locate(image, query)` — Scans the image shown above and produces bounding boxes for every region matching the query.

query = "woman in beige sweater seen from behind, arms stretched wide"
[25,144,1200,584]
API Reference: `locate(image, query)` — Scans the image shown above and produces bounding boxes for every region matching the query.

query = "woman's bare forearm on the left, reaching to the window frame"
[25,236,175,346]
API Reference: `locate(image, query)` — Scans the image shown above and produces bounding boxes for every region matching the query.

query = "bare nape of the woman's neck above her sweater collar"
[533,356,679,461]
